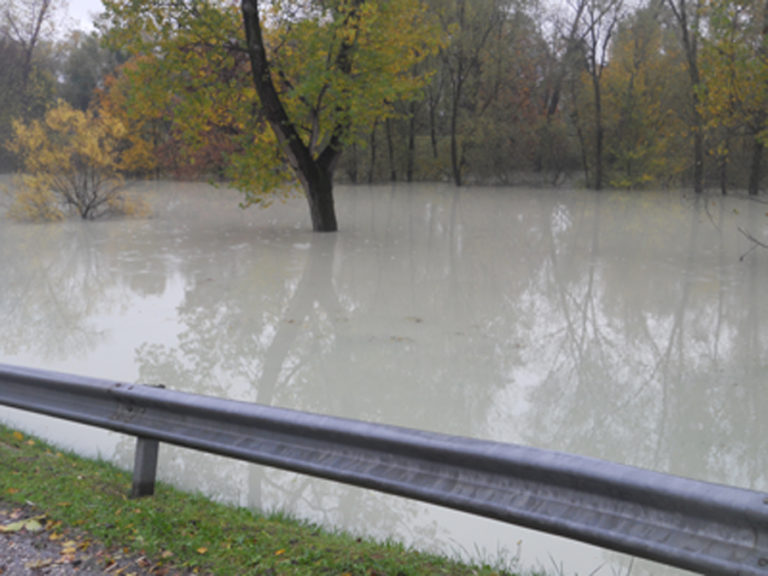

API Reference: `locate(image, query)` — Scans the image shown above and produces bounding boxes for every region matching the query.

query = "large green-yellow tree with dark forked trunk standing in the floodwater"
[105,0,438,231]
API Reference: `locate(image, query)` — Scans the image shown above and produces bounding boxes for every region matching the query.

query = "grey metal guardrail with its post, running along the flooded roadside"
[0,364,768,576]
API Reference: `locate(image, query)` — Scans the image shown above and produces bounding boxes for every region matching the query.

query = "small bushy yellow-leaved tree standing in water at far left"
[8,100,152,220]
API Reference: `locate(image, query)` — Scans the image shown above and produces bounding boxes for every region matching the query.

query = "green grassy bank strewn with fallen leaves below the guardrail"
[0,426,520,576]
